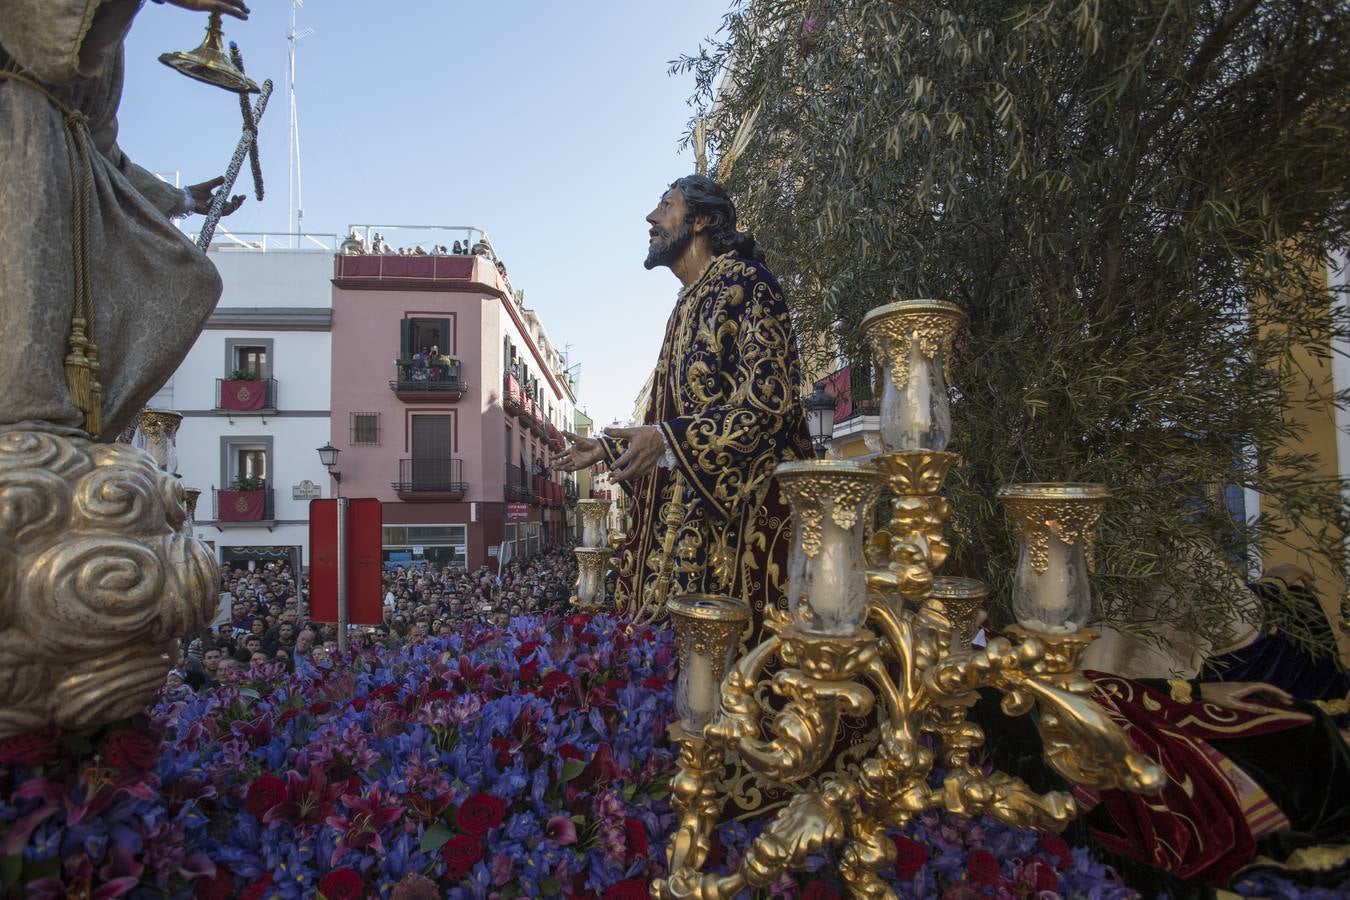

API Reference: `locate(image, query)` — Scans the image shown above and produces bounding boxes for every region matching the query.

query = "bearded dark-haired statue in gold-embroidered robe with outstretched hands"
[554,175,811,623]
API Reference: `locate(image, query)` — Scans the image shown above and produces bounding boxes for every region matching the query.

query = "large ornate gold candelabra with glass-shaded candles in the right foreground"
[652,301,1164,900]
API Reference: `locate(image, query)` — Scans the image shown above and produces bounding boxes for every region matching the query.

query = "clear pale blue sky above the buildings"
[120,0,729,424]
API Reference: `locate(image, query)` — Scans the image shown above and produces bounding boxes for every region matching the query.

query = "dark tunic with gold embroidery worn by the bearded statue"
[601,254,811,634]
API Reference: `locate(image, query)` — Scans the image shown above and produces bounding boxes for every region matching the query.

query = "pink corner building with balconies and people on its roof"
[332,254,575,568]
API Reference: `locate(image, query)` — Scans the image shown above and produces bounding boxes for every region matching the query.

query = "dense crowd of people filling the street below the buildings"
[167,548,576,692]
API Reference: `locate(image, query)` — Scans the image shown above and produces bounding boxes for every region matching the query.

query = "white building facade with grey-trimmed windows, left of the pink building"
[150,239,333,571]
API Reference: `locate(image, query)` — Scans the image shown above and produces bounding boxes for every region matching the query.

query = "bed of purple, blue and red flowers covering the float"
[0,615,1328,900]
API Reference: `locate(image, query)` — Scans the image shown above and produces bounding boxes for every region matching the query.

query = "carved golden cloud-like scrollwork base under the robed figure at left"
[0,430,219,738]
